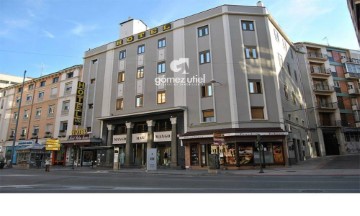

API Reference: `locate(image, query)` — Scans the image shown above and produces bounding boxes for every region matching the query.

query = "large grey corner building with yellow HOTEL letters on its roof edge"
[83,2,314,170]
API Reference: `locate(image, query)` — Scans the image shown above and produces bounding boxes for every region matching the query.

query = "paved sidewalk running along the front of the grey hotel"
[5,154,360,176]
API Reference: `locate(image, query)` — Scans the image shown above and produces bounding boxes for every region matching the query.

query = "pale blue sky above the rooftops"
[0,0,359,77]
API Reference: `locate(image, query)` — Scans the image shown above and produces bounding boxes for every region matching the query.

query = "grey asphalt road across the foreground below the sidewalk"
[0,169,360,193]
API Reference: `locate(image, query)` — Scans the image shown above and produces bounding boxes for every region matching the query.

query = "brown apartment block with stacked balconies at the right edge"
[297,42,360,156]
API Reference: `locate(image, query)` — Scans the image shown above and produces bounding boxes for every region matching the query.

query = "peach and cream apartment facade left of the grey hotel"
[0,65,82,165]
